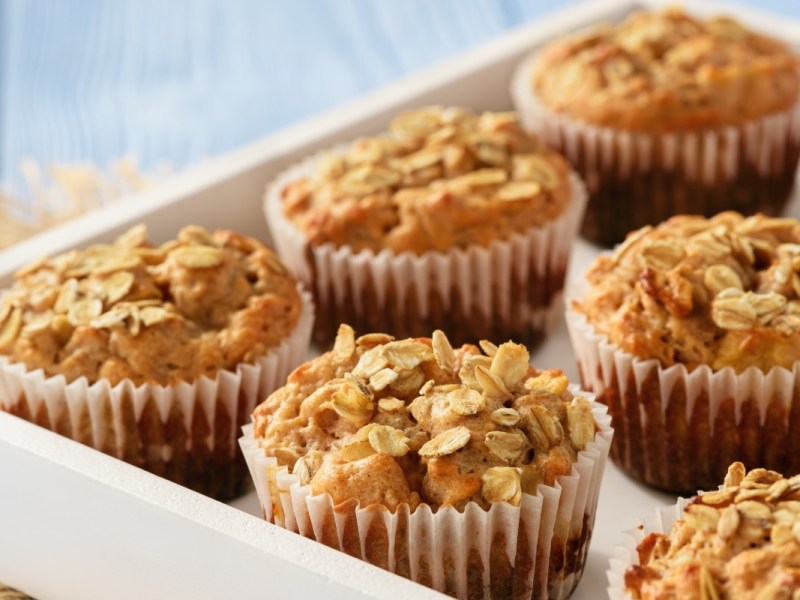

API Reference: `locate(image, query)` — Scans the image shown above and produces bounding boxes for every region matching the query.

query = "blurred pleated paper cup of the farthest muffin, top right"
[511,55,800,246]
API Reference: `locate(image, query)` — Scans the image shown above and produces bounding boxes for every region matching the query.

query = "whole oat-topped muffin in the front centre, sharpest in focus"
[241,325,612,598]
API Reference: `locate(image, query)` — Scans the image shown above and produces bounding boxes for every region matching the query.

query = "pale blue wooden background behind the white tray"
[0,0,800,196]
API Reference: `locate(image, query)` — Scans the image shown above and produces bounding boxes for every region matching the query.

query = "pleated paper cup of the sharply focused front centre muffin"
[239,389,613,599]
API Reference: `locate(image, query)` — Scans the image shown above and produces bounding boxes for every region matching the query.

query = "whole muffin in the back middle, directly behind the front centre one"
[266,107,585,347]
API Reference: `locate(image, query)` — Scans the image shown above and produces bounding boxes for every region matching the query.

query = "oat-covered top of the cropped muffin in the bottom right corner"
[625,462,800,600]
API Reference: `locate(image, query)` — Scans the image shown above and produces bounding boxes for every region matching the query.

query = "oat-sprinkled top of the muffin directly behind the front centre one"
[282,107,570,254]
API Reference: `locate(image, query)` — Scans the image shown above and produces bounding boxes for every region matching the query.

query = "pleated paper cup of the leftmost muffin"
[0,291,314,500]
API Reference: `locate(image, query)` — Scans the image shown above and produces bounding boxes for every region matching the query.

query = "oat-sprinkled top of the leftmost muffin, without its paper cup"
[0,225,301,385]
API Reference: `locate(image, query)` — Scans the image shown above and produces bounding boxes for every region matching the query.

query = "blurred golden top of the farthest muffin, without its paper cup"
[532,8,800,131]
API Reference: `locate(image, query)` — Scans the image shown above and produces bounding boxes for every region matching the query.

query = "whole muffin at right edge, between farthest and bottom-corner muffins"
[567,212,800,493]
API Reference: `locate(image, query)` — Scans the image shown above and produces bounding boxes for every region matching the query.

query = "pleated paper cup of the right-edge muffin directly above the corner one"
[567,309,800,494]
